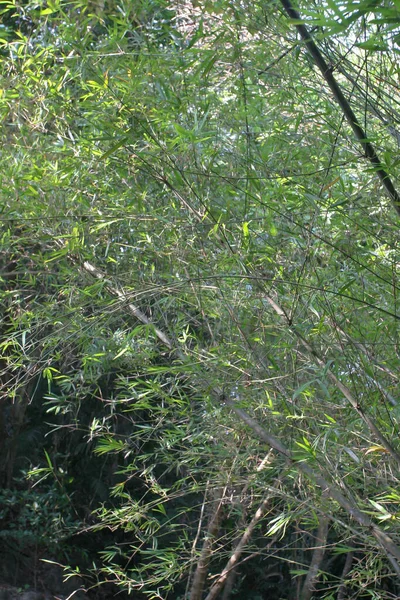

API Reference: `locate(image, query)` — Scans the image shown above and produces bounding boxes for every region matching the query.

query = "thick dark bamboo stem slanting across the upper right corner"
[281,0,400,215]
